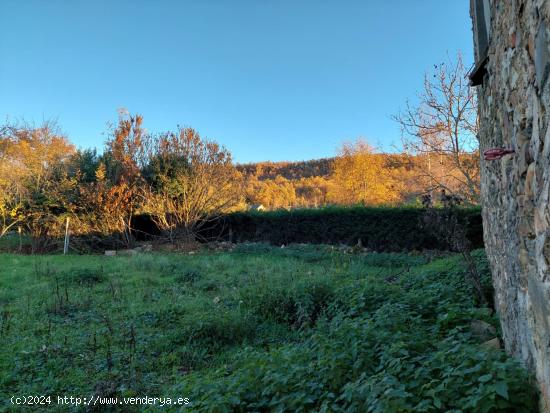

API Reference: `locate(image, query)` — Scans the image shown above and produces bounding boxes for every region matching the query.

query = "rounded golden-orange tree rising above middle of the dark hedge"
[330,139,400,205]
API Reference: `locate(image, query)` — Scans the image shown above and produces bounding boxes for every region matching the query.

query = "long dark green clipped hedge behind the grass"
[201,207,483,251]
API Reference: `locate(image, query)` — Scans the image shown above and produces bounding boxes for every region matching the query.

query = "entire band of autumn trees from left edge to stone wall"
[0,53,479,251]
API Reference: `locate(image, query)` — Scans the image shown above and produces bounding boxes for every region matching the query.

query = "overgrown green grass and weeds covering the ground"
[0,244,536,413]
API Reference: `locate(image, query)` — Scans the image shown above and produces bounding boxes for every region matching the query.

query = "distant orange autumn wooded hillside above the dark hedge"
[236,148,479,209]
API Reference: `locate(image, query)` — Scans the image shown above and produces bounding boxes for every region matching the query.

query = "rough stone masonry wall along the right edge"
[470,0,550,412]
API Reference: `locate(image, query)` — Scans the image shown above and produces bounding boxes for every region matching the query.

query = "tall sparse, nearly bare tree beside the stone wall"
[394,54,479,204]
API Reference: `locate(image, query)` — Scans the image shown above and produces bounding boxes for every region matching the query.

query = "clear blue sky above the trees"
[0,0,473,162]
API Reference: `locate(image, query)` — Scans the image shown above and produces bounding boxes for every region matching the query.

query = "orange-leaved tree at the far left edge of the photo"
[0,122,75,251]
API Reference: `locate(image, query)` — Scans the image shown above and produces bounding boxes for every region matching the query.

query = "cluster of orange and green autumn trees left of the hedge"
[0,114,242,251]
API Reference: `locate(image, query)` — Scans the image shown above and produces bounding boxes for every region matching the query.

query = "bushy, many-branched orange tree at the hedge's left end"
[145,128,242,241]
